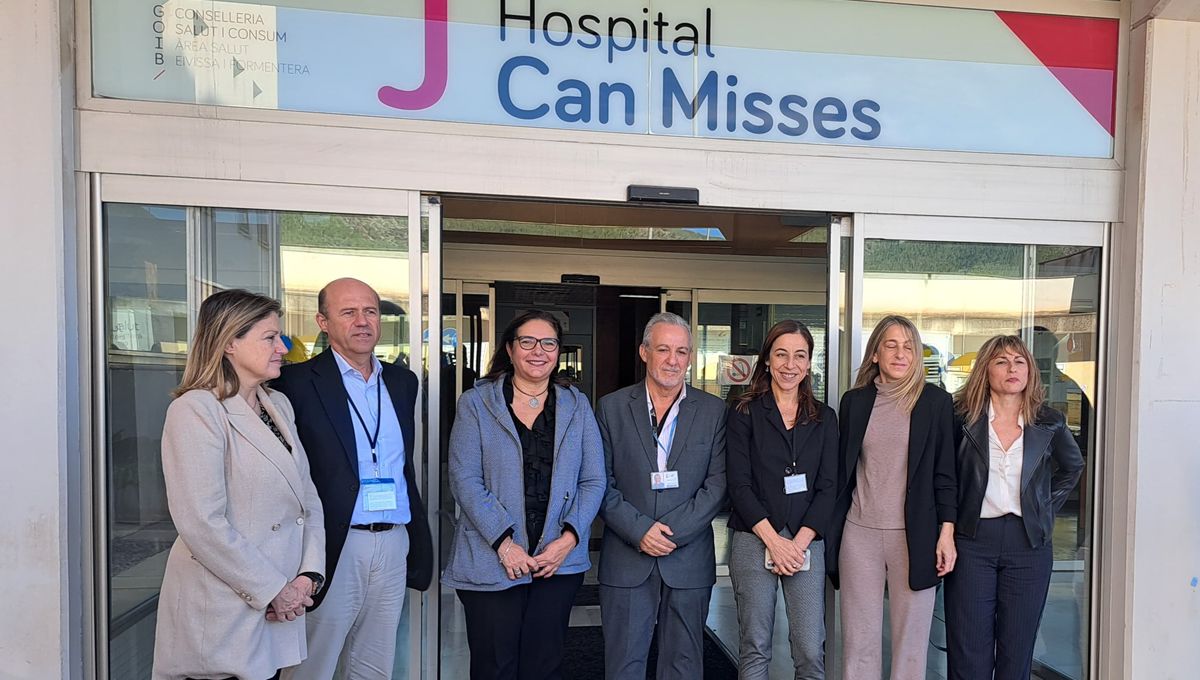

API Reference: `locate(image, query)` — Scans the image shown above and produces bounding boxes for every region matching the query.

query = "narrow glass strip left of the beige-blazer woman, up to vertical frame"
[103,204,188,679]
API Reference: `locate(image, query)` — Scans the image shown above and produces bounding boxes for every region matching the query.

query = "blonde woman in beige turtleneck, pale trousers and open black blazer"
[826,315,958,680]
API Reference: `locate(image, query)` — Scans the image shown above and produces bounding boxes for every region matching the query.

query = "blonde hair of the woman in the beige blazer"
[172,288,281,399]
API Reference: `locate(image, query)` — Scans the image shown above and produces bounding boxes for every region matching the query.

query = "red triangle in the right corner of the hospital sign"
[996,12,1120,134]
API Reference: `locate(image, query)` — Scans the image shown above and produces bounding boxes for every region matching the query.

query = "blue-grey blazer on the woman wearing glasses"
[442,380,604,590]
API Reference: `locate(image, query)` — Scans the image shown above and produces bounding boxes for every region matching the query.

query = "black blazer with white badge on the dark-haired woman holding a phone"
[725,392,838,538]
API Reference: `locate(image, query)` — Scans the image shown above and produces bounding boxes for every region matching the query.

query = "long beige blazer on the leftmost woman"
[154,387,325,680]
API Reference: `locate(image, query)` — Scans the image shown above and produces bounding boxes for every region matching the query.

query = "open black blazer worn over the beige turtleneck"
[826,384,958,590]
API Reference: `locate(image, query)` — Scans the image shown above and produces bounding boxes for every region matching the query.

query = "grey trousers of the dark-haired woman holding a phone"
[730,531,826,680]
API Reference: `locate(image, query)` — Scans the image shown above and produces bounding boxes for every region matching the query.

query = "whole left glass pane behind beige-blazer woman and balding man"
[103,203,410,680]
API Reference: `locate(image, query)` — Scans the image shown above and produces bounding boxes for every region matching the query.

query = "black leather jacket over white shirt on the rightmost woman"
[954,405,1084,548]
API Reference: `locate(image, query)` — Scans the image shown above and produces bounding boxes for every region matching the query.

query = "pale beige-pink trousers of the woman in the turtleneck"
[838,520,937,680]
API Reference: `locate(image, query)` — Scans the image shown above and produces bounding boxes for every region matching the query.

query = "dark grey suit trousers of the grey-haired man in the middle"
[600,565,713,680]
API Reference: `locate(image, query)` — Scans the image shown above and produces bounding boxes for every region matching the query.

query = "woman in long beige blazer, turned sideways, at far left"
[152,290,325,680]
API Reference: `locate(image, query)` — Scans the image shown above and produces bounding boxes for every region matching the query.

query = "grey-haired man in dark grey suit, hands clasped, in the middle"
[596,313,725,680]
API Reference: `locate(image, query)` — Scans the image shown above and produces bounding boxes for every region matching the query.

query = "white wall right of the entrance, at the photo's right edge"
[1100,14,1200,680]
